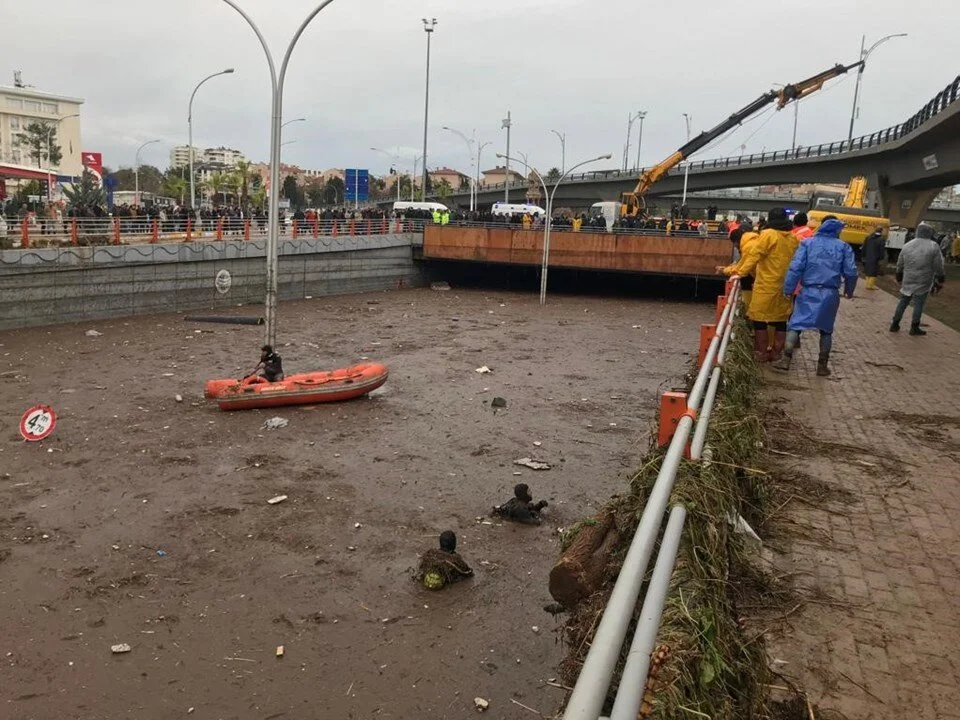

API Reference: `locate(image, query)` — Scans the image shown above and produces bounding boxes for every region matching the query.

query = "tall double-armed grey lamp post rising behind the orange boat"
[223,0,333,345]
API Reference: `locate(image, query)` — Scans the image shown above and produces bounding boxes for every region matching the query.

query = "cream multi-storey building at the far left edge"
[0,73,83,175]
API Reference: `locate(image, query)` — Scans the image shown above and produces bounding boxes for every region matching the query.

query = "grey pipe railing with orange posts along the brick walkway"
[563,278,740,720]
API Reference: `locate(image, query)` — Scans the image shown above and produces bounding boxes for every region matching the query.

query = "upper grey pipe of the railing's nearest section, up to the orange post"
[563,410,692,720]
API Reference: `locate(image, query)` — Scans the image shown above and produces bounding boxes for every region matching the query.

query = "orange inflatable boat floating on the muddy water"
[204,363,389,410]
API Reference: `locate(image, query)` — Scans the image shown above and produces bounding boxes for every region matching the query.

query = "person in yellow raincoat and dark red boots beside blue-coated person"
[722,208,800,362]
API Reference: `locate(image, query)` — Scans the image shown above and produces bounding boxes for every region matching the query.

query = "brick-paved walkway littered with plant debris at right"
[764,290,960,720]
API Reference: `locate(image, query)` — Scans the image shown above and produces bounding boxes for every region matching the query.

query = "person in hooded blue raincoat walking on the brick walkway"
[773,215,857,377]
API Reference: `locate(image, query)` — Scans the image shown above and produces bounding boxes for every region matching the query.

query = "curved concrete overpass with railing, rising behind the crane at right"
[446,71,960,227]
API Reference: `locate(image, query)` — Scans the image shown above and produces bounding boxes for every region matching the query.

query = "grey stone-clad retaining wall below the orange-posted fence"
[0,234,423,330]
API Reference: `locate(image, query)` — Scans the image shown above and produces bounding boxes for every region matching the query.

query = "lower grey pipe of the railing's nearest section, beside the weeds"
[610,505,687,720]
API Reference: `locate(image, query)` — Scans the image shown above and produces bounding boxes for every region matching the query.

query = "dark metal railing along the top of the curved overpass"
[466,76,960,192]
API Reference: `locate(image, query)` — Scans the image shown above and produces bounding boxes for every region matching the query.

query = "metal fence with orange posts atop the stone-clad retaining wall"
[7,217,423,248]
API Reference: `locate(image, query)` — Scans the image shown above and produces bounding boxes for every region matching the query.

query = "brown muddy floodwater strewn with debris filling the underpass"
[0,289,712,720]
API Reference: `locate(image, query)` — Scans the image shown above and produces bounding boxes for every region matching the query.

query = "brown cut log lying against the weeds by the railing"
[550,511,620,610]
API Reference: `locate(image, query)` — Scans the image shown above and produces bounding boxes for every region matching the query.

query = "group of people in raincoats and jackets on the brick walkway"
[717,208,945,377]
